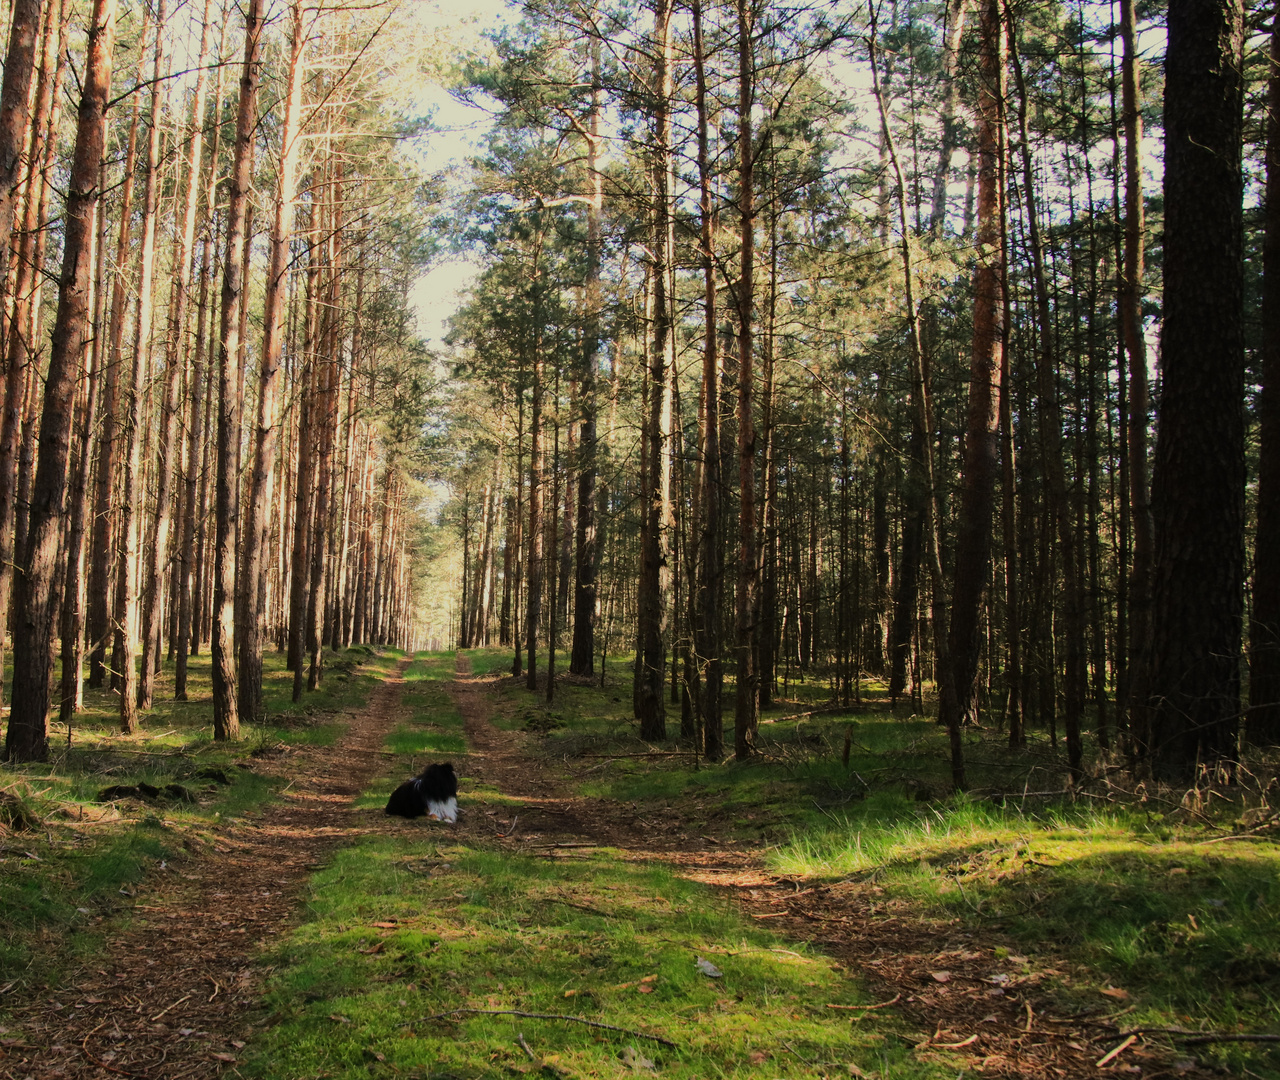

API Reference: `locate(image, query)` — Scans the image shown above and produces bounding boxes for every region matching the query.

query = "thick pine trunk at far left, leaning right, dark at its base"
[5,0,115,761]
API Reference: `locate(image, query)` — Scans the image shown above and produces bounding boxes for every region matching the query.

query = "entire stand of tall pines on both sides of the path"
[0,0,1280,786]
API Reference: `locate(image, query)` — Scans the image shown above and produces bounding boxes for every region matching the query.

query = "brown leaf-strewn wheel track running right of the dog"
[451,654,1221,1080]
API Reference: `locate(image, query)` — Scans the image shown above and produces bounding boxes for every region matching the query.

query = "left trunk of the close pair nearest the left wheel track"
[212,0,262,740]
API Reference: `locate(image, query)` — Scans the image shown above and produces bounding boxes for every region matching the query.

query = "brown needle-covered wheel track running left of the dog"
[0,659,410,1080]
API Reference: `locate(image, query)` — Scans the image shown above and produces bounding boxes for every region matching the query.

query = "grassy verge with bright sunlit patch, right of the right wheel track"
[455,650,1280,1076]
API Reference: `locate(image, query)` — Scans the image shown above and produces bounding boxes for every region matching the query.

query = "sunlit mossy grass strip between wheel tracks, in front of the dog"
[241,844,950,1079]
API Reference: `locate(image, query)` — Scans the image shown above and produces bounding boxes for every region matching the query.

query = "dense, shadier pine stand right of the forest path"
[440,0,1274,784]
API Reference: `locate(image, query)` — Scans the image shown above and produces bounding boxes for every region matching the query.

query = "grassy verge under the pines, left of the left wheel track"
[0,649,396,989]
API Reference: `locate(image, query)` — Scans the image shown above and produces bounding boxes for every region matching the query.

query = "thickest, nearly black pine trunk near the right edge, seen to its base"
[1147,0,1244,781]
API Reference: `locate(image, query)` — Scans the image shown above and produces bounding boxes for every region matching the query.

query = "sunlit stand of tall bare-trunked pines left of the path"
[0,0,433,760]
